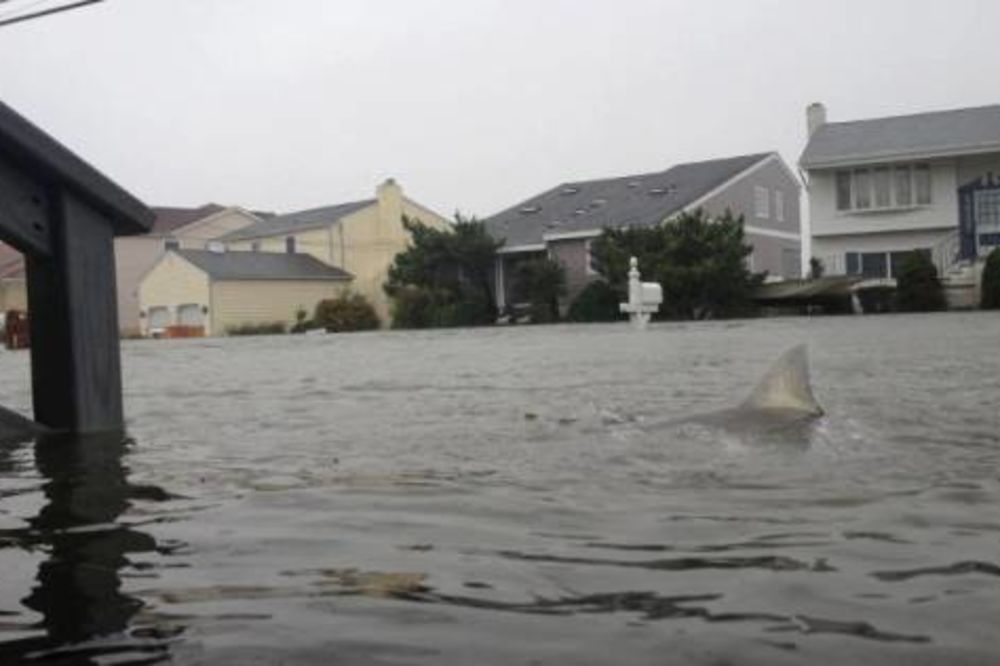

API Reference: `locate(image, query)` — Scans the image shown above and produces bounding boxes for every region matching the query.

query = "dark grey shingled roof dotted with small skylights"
[485,153,776,247]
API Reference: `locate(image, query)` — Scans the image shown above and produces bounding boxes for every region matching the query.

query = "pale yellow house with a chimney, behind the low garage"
[225,178,449,324]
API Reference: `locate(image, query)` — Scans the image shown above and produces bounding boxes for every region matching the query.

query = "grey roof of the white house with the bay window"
[799,105,1000,169]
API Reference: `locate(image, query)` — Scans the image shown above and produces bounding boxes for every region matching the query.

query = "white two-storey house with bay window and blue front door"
[799,104,1000,305]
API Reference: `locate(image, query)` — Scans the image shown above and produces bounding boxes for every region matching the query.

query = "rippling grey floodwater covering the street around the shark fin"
[0,313,1000,665]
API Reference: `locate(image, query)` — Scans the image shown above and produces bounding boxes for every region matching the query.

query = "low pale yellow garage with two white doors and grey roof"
[139,247,351,335]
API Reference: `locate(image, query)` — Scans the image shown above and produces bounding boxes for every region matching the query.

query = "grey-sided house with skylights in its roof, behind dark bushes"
[485,153,801,308]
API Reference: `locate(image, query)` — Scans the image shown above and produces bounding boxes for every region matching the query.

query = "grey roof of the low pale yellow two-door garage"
[173,250,353,280]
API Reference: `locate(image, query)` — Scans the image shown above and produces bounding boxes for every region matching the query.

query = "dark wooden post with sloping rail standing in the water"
[0,98,153,432]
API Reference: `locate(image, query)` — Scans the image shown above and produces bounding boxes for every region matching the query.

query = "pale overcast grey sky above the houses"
[0,0,1000,216]
